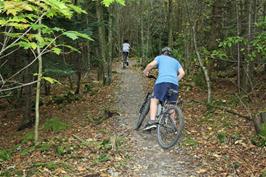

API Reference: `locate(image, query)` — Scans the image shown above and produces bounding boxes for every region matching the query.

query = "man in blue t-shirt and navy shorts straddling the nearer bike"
[143,47,185,130]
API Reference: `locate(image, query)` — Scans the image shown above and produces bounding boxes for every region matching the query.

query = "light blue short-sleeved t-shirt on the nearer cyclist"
[154,55,181,85]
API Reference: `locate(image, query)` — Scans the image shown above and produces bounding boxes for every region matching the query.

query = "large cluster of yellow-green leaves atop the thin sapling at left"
[0,0,92,55]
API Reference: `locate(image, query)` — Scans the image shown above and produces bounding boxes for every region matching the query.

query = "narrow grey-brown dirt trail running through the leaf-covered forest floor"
[116,61,196,177]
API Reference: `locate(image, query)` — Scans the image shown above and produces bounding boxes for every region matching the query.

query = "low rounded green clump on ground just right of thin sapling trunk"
[44,117,68,132]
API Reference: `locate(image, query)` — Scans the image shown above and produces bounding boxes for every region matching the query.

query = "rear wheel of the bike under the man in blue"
[157,105,184,149]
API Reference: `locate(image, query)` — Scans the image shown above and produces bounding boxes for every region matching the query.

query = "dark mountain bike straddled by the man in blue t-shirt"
[134,76,184,149]
